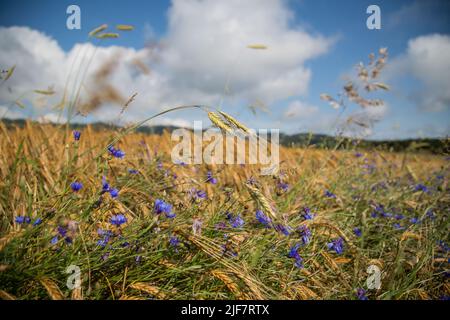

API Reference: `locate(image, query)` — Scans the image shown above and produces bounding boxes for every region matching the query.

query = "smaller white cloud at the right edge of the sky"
[389,34,450,112]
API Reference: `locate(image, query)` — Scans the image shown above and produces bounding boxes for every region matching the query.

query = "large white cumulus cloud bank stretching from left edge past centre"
[0,0,333,126]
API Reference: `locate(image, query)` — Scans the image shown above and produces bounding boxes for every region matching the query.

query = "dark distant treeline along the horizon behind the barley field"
[0,119,450,154]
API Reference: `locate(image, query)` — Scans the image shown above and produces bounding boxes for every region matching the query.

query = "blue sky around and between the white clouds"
[0,0,450,138]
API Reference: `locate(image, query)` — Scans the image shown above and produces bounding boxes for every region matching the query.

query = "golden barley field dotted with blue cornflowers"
[0,122,450,300]
